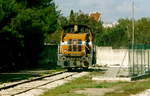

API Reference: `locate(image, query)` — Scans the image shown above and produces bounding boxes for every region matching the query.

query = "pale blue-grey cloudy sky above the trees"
[55,0,150,23]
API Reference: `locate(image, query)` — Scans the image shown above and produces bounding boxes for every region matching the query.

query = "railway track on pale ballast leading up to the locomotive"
[0,71,87,96]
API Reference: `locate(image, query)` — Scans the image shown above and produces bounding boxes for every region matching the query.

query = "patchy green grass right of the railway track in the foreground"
[41,72,150,96]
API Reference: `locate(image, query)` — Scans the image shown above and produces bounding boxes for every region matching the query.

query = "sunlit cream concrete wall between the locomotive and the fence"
[96,47,129,67]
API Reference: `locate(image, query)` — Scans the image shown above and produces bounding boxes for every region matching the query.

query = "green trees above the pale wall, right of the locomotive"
[96,18,150,48]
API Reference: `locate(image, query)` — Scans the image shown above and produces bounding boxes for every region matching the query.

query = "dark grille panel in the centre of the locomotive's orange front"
[68,39,82,52]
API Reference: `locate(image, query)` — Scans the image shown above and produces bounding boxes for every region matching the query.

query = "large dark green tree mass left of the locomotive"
[0,0,59,69]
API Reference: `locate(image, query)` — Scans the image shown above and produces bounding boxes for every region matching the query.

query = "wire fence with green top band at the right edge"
[129,44,150,77]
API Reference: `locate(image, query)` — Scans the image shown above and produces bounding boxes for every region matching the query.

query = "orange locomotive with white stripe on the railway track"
[58,25,94,69]
